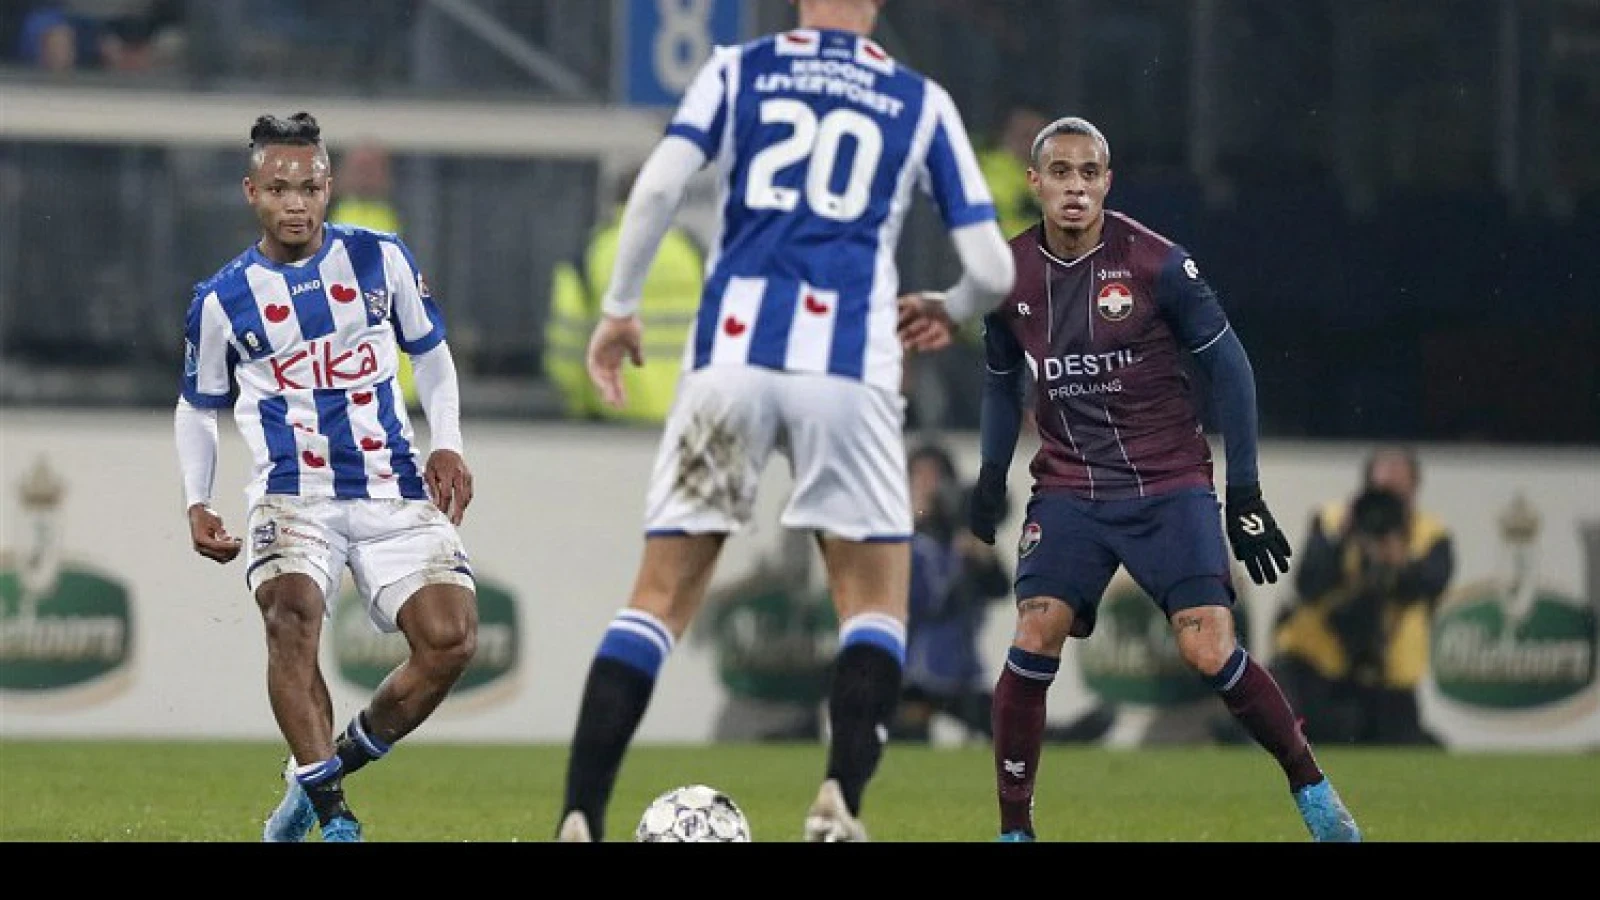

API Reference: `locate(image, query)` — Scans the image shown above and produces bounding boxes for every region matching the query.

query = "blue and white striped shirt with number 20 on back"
[667,30,995,391]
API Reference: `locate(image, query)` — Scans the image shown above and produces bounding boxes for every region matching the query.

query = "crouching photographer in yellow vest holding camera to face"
[1272,447,1454,745]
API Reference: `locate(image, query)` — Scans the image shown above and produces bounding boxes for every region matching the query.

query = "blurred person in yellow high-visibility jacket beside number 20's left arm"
[544,170,706,424]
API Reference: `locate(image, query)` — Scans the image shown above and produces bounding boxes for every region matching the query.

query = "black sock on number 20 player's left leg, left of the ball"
[562,657,656,841]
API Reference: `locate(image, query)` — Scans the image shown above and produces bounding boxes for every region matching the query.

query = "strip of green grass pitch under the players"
[0,740,1600,842]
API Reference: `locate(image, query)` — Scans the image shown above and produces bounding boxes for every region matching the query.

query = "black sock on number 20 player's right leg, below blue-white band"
[827,642,902,815]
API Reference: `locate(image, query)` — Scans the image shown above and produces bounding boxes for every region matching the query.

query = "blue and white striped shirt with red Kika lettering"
[182,224,445,503]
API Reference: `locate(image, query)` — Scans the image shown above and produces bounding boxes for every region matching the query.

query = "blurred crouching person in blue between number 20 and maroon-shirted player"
[891,445,1011,741]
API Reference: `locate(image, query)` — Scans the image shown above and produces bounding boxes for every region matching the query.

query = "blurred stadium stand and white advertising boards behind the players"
[0,0,1600,748]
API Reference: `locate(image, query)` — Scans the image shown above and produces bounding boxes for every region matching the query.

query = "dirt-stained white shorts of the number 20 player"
[645,365,912,541]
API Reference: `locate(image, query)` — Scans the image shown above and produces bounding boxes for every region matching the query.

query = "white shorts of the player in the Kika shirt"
[245,493,475,633]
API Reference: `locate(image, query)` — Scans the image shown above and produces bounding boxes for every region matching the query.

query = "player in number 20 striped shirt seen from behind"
[557,0,1014,842]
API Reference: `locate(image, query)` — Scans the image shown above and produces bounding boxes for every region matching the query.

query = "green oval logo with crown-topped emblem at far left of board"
[0,460,133,698]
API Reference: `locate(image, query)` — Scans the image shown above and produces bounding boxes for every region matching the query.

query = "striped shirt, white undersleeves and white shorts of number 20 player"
[605,27,1013,540]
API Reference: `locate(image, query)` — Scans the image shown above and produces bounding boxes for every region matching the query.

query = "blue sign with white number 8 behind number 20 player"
[616,0,744,106]
